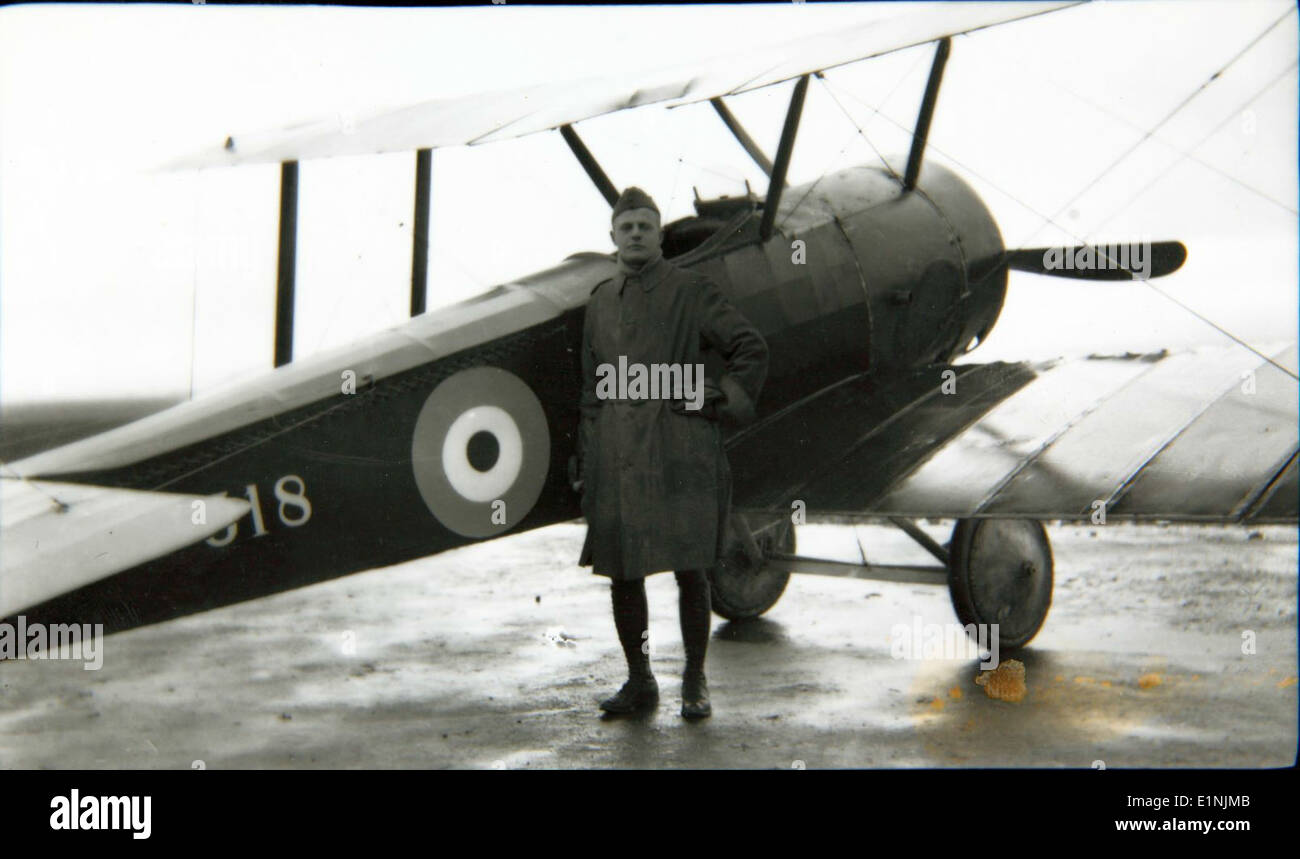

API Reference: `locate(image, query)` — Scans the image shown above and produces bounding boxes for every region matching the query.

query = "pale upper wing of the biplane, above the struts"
[170,0,1076,168]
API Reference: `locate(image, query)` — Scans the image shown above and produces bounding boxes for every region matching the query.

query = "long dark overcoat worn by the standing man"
[579,255,767,580]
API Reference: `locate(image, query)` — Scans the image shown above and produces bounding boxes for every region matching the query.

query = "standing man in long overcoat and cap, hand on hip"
[575,187,767,719]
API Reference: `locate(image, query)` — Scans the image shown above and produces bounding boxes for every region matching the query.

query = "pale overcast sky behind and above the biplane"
[0,0,1297,403]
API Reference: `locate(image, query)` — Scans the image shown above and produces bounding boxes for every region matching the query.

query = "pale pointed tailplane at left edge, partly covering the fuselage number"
[0,478,248,617]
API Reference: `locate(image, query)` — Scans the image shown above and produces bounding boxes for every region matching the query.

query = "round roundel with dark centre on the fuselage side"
[411,366,551,537]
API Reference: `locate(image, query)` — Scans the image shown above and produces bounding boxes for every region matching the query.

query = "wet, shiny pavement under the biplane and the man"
[0,524,1297,769]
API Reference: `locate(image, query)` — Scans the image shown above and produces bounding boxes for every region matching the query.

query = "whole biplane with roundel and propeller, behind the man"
[0,3,1297,647]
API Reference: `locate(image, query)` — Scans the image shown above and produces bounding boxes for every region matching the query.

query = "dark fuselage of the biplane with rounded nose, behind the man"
[10,164,1006,630]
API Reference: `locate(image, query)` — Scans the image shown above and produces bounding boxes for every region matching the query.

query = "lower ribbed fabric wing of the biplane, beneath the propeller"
[728,346,1300,522]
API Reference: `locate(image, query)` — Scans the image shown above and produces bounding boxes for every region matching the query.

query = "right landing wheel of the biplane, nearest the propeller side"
[948,519,1053,648]
